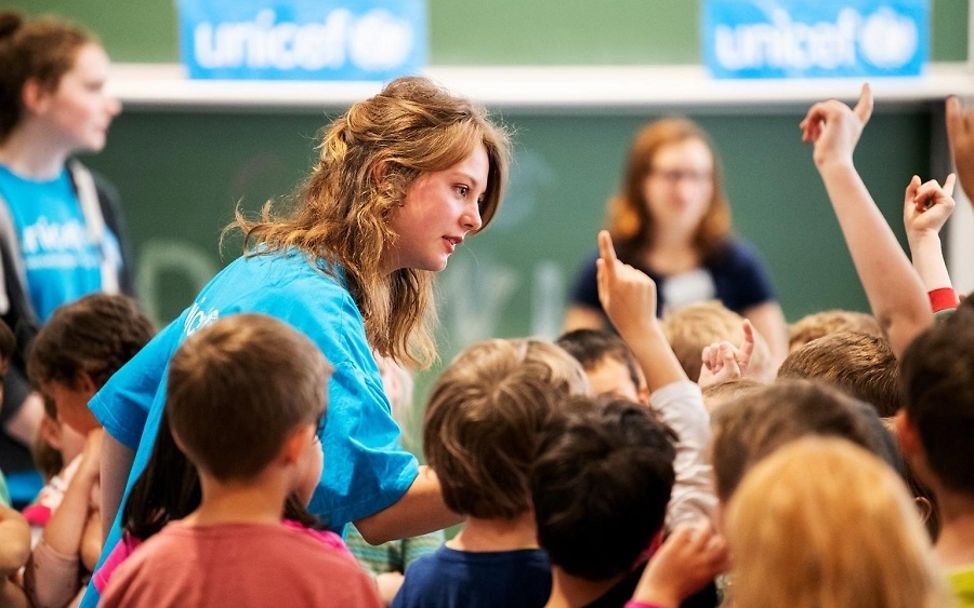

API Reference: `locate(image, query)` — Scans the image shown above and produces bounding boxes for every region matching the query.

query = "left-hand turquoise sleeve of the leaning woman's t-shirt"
[88,313,185,450]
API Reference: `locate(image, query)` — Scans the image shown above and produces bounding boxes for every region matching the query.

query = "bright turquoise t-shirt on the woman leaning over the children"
[82,253,419,606]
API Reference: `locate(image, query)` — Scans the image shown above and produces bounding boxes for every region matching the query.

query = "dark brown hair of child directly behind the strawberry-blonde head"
[711,380,885,504]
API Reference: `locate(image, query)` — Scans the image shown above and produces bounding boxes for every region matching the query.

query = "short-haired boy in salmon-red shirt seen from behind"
[101,314,379,608]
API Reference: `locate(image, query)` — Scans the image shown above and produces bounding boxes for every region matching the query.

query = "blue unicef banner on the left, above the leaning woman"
[177,0,427,80]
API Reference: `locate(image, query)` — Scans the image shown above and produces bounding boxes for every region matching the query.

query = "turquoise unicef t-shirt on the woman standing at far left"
[0,165,122,323]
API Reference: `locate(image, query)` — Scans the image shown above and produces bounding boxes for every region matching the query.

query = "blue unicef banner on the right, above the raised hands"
[703,0,930,78]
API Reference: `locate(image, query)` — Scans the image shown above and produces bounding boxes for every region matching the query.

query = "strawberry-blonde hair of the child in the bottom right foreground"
[725,438,946,608]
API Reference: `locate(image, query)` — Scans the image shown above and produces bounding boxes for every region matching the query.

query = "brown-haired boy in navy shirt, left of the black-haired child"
[392,340,588,608]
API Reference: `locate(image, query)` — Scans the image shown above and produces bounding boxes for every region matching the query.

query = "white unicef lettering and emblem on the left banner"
[193,8,415,71]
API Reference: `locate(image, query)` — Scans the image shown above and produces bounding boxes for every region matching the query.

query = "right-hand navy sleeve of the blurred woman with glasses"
[709,240,775,313]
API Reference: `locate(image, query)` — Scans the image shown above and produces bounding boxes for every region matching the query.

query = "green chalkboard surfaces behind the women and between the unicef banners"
[7,0,969,420]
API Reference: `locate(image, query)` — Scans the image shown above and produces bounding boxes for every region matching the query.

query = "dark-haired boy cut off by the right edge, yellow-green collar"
[896,304,974,607]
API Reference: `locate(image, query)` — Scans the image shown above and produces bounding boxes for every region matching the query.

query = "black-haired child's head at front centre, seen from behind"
[531,398,676,581]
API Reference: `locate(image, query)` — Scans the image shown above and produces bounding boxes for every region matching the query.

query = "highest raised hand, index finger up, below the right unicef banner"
[798,83,873,167]
